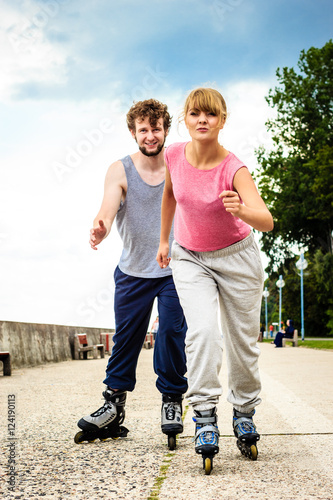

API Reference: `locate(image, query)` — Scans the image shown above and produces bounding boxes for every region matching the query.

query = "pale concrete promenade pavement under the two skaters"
[0,344,333,500]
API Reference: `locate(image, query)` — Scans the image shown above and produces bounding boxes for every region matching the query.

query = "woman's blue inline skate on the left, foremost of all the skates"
[193,407,220,475]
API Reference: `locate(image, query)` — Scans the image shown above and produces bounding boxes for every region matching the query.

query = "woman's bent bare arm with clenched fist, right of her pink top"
[219,168,274,232]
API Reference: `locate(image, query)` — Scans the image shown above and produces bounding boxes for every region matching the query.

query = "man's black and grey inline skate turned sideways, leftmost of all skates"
[74,388,129,444]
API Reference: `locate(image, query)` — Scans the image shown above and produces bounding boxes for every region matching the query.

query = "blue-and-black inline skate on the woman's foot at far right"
[233,409,260,460]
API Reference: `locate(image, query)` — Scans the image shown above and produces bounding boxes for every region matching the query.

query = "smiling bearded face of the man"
[131,118,167,156]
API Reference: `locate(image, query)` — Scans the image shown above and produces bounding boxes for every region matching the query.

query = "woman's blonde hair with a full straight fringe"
[179,87,227,126]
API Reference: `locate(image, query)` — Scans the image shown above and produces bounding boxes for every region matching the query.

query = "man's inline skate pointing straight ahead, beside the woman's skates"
[161,394,183,450]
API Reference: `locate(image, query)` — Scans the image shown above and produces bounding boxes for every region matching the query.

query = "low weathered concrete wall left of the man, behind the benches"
[0,321,114,370]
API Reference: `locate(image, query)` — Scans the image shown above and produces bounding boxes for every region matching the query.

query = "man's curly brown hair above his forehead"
[126,99,172,132]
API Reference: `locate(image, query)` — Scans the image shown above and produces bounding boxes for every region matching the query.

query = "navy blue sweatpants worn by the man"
[104,267,187,395]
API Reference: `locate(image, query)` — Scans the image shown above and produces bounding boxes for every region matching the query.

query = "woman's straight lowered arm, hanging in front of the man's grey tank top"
[156,168,177,269]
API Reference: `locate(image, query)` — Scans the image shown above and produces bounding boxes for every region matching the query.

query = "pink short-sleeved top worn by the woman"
[165,142,251,252]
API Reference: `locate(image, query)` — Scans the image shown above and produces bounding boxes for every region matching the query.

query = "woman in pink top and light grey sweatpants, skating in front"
[156,88,273,474]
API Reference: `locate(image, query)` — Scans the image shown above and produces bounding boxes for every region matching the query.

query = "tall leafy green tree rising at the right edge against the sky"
[257,40,333,270]
